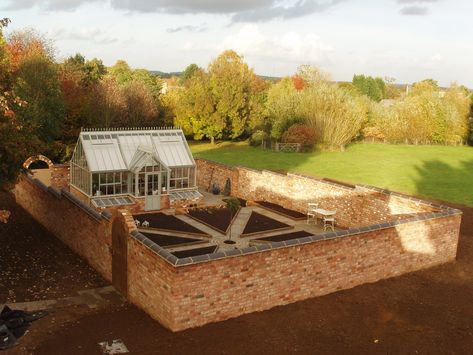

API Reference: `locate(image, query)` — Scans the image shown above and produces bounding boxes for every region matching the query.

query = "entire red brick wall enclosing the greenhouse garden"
[15,160,461,331]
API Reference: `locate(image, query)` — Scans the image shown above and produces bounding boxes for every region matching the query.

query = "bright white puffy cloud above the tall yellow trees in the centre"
[216,25,333,63]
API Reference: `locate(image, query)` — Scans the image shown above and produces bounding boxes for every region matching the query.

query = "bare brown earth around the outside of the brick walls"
[0,194,473,354]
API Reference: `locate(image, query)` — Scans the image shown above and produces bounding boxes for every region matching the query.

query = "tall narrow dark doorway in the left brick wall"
[112,212,128,298]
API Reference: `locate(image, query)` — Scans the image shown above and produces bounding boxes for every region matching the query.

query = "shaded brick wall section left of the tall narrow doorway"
[15,177,112,280]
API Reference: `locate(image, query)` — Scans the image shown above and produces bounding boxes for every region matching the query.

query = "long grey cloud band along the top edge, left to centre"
[0,0,344,22]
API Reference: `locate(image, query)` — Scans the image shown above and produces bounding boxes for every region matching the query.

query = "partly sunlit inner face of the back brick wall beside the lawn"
[196,159,433,228]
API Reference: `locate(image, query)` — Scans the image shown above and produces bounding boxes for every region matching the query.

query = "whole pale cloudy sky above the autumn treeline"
[0,0,473,88]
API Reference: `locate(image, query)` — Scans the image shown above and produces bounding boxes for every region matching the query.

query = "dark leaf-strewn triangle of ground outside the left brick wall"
[0,192,108,304]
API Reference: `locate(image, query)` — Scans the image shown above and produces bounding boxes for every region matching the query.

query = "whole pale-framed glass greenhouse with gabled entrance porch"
[70,128,200,210]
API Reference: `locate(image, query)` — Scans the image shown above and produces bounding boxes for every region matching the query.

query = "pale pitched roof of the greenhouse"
[79,129,195,172]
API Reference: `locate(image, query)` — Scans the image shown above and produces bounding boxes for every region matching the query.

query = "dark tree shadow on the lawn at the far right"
[414,160,473,206]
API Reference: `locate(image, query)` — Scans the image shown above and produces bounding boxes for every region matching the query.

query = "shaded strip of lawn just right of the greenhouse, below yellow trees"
[191,142,320,173]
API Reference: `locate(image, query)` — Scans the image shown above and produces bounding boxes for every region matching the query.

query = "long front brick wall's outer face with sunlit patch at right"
[157,215,460,331]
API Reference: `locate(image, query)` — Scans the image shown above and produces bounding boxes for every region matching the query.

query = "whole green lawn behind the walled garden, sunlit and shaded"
[191,143,473,206]
